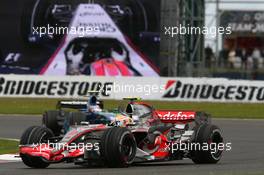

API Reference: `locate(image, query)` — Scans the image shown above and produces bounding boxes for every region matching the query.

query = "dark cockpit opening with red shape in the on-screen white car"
[65,38,141,76]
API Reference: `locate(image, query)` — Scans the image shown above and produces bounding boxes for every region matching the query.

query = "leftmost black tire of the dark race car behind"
[42,111,64,136]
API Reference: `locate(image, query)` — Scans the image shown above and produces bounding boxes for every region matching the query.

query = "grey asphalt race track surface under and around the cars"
[0,116,264,175]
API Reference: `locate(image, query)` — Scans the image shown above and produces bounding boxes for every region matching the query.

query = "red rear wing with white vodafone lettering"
[157,111,195,121]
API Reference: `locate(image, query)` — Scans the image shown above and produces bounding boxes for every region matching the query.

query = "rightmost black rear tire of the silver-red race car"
[191,124,224,164]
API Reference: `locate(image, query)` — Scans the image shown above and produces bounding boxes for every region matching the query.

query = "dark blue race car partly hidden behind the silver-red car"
[42,91,115,136]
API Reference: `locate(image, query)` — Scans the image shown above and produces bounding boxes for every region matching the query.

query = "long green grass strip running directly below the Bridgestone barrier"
[0,98,264,119]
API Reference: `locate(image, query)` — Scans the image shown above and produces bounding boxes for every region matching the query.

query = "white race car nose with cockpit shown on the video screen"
[40,4,159,77]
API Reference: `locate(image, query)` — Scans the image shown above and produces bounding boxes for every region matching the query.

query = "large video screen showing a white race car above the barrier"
[0,0,160,77]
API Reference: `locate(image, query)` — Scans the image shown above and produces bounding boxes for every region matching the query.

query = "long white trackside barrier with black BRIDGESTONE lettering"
[0,75,264,103]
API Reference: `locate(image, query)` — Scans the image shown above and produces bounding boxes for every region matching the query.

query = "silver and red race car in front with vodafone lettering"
[19,99,223,168]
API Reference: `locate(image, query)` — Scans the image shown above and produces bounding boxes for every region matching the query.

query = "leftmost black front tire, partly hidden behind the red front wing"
[20,126,54,168]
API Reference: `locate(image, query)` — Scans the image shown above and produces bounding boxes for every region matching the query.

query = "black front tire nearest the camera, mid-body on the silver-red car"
[100,127,137,168]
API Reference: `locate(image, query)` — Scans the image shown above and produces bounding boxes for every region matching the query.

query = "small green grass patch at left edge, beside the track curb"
[0,139,19,154]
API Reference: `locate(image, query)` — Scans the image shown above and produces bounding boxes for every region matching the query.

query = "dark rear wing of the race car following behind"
[57,100,88,109]
